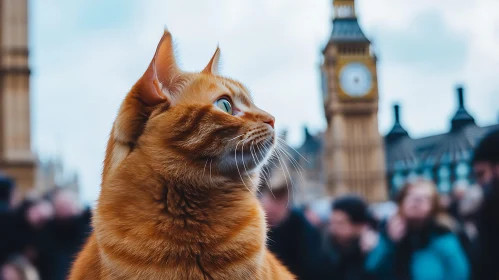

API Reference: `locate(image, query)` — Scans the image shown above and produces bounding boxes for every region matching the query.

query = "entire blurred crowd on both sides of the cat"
[0,131,499,280]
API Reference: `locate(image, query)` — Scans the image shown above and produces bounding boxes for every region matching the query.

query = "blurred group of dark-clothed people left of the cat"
[0,186,91,280]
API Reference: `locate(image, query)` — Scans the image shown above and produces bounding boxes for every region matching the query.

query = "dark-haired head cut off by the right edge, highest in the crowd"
[472,129,499,186]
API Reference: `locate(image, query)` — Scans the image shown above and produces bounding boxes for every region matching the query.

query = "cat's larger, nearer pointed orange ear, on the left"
[139,29,181,106]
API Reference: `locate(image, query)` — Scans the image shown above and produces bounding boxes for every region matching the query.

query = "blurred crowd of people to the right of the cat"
[260,131,499,280]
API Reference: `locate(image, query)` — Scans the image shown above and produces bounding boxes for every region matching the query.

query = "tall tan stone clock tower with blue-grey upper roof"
[321,0,387,202]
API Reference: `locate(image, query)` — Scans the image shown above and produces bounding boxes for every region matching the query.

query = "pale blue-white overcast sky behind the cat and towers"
[30,0,499,202]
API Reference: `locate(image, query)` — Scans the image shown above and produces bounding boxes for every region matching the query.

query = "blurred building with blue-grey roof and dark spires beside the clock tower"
[385,87,499,196]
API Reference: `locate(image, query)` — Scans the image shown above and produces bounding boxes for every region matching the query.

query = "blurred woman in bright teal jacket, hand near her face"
[366,178,470,280]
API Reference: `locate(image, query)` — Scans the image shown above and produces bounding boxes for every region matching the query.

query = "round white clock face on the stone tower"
[340,62,373,97]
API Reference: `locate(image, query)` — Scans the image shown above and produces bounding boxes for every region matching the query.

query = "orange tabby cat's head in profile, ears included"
[104,31,275,183]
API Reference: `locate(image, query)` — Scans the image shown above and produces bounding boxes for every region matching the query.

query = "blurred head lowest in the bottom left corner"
[0,255,40,280]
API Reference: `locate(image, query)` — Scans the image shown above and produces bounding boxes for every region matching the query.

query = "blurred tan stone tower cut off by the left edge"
[0,0,36,191]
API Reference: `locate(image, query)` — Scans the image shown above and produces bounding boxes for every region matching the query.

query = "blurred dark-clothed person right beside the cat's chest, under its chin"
[260,172,324,280]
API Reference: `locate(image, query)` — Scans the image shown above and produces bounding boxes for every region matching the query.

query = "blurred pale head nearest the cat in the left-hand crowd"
[52,188,82,219]
